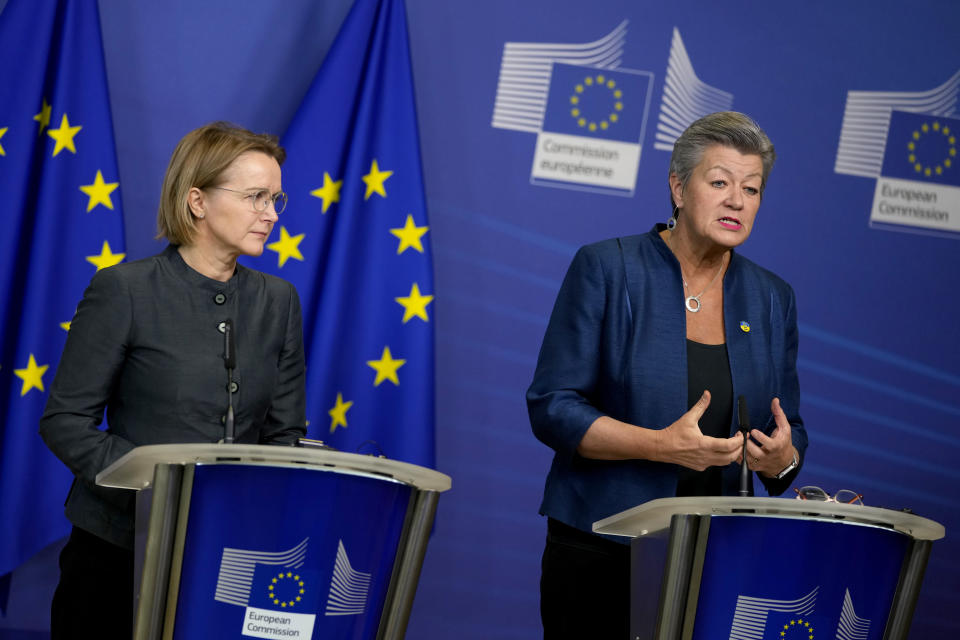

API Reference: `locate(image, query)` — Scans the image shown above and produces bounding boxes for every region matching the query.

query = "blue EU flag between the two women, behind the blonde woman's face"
[244,0,434,466]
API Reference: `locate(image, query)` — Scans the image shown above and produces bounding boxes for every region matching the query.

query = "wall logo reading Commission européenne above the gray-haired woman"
[491,20,733,196]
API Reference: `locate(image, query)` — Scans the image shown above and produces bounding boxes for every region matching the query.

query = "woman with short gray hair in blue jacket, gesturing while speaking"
[527,111,807,640]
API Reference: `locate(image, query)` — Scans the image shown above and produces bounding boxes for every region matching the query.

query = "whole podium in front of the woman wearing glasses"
[97,444,450,640]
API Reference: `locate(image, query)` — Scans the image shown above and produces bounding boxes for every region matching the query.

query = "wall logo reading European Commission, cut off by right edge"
[835,71,960,234]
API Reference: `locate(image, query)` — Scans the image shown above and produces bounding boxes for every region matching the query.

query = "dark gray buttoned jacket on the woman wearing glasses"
[40,246,306,548]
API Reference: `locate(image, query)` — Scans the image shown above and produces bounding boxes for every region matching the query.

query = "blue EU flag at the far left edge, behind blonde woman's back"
[0,0,124,575]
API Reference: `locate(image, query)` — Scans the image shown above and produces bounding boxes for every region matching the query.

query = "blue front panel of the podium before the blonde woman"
[173,465,411,640]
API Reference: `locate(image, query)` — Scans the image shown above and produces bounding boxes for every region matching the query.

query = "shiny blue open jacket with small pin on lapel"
[527,225,807,531]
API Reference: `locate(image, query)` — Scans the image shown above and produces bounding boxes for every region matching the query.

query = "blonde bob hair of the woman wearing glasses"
[157,122,287,245]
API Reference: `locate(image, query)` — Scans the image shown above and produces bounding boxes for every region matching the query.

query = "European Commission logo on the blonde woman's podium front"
[214,538,371,638]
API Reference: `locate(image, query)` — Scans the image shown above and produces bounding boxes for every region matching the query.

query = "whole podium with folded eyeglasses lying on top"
[593,497,944,640]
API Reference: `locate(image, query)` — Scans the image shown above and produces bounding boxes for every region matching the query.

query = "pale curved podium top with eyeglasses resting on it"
[593,497,944,540]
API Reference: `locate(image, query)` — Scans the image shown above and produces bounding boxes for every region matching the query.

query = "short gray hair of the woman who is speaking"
[667,111,777,208]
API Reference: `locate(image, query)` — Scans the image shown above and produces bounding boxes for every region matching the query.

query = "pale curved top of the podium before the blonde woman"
[97,444,451,491]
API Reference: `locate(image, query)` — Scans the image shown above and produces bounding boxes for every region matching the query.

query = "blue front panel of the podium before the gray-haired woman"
[692,516,909,640]
